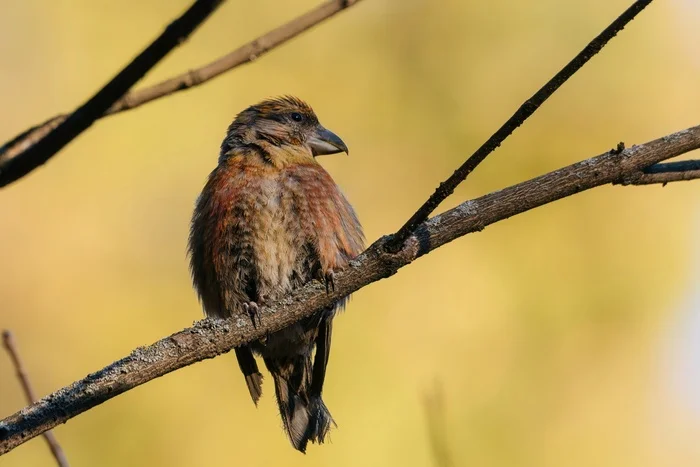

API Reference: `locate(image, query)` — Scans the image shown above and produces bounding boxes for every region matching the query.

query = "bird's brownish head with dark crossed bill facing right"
[221,96,348,164]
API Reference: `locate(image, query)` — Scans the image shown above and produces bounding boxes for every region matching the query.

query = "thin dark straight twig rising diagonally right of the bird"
[388,0,652,251]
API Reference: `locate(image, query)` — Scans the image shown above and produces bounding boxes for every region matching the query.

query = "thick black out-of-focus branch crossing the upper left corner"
[0,0,224,187]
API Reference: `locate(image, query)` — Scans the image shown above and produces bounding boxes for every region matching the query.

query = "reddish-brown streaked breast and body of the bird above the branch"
[204,158,362,310]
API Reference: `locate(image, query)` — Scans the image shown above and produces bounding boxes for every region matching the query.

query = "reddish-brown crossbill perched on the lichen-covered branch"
[188,96,365,453]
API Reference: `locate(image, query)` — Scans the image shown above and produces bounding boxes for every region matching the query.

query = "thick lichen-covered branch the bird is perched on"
[0,126,700,454]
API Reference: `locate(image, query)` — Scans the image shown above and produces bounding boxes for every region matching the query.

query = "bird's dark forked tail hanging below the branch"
[265,355,335,452]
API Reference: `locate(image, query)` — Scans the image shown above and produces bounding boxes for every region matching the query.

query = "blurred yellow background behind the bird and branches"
[0,0,700,467]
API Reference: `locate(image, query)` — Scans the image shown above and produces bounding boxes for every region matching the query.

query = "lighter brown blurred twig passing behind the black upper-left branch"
[0,0,361,186]
